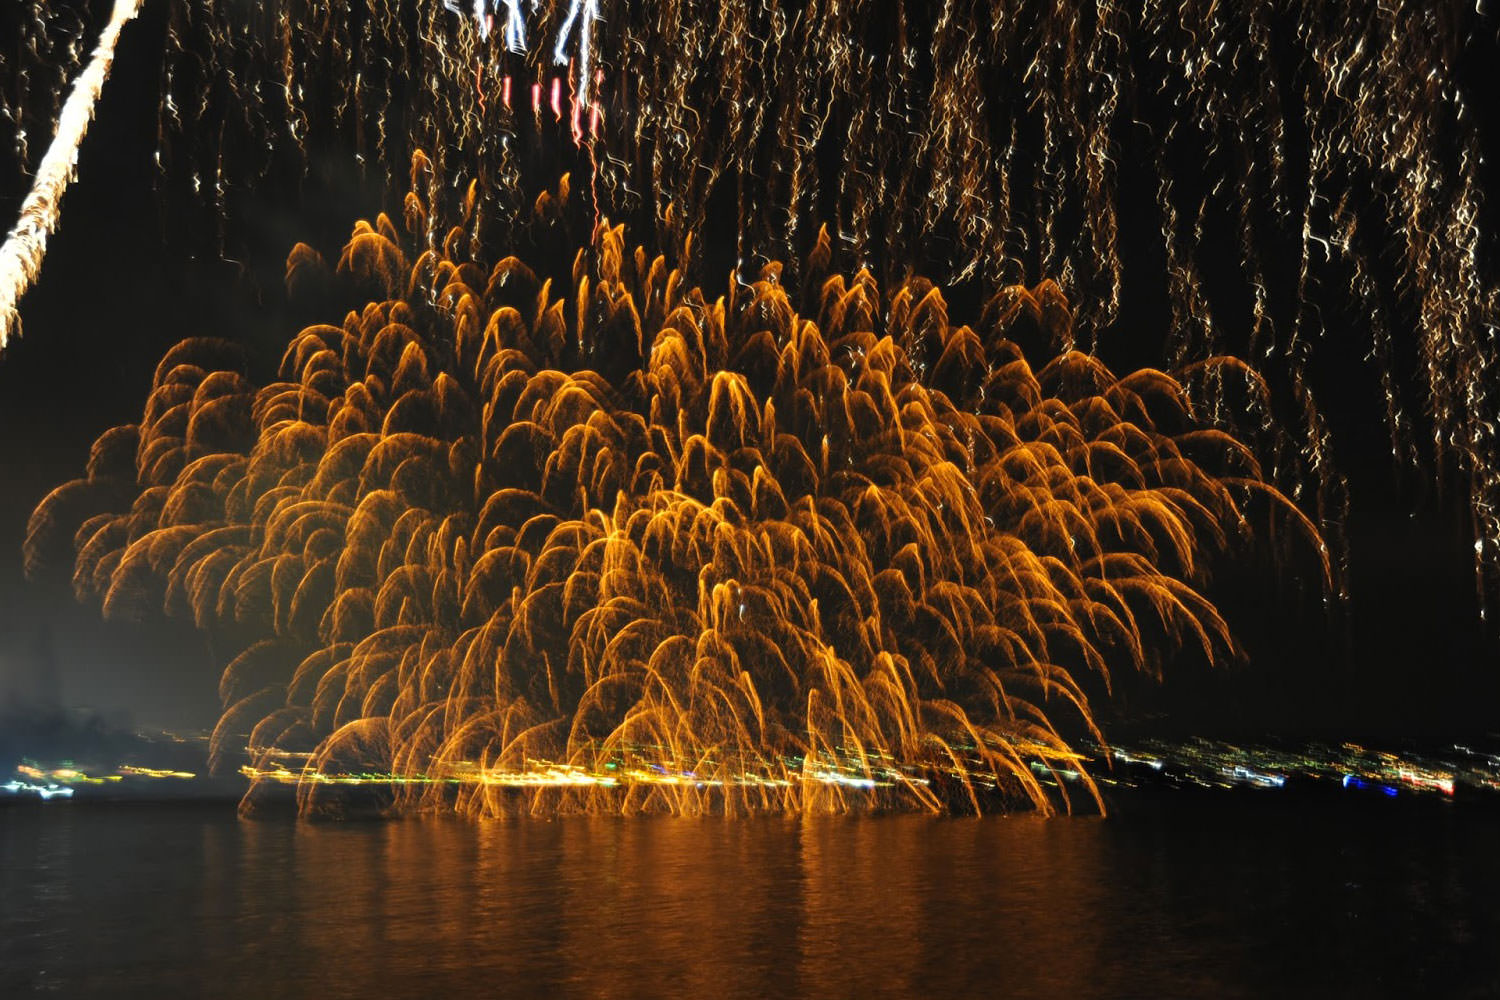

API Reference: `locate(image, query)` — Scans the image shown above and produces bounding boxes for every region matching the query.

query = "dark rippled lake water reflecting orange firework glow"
[0,795,1500,999]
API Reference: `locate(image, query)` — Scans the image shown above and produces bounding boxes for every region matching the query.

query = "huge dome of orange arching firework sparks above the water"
[20,157,1316,814]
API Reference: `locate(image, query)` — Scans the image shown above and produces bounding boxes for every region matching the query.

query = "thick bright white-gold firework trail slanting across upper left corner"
[0,0,143,349]
